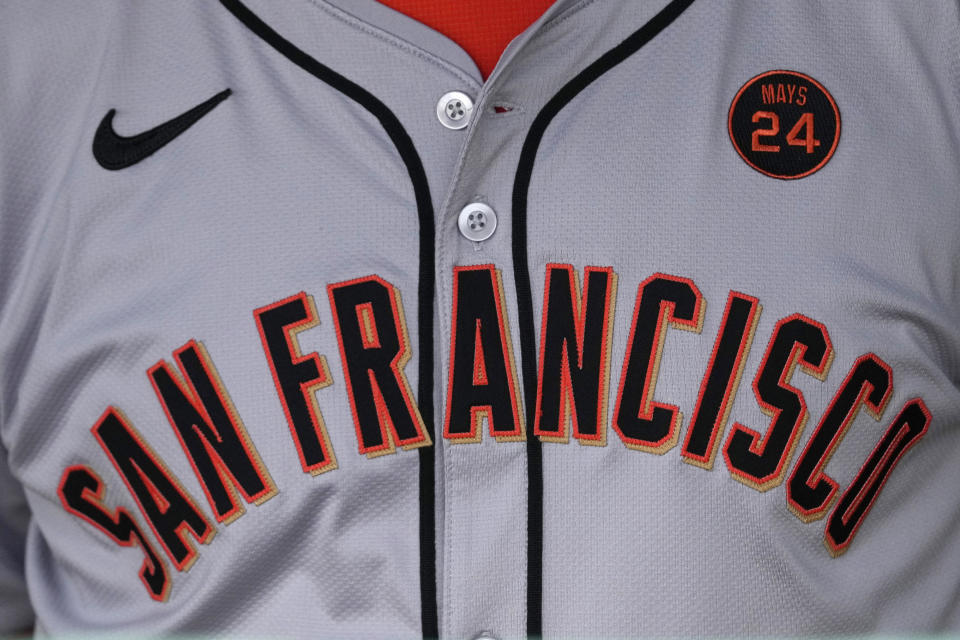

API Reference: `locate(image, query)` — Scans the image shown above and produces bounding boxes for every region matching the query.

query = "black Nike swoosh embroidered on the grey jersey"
[93,89,232,171]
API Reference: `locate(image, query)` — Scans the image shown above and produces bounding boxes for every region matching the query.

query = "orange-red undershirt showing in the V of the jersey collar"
[380,0,553,80]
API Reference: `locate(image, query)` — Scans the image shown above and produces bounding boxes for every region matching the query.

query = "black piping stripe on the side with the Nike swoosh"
[220,0,440,638]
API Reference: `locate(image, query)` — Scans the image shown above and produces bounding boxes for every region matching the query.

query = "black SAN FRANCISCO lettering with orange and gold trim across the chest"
[58,262,931,601]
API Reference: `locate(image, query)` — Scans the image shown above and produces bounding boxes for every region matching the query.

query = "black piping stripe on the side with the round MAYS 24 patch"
[513,0,693,637]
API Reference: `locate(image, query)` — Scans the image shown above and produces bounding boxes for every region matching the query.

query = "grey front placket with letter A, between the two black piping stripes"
[435,12,580,637]
